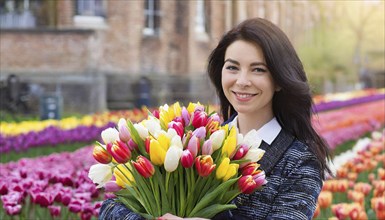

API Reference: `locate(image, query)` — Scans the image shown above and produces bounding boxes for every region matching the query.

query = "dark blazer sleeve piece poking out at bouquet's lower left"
[98,199,144,220]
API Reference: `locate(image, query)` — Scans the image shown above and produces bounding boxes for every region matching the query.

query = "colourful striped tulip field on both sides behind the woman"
[0,89,385,220]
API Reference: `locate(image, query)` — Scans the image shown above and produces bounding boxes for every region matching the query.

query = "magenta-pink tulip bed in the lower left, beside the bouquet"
[0,146,111,219]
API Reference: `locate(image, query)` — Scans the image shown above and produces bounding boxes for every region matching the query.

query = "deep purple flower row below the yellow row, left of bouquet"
[0,122,115,154]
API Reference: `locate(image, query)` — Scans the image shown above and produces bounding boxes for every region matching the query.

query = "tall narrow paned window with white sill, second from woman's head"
[143,0,161,35]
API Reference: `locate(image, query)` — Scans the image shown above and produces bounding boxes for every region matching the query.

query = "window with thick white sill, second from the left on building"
[74,0,107,28]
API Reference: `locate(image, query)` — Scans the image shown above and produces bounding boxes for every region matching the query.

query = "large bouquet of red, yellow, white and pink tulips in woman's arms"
[89,102,266,219]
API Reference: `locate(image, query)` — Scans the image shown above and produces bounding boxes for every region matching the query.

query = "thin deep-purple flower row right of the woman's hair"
[313,94,385,112]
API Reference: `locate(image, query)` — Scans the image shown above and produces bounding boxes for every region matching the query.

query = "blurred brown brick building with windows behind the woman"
[0,0,317,113]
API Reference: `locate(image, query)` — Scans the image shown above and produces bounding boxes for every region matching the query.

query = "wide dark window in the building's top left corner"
[0,0,40,28]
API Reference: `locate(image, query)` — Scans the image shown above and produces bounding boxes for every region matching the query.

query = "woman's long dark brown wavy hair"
[207,18,331,178]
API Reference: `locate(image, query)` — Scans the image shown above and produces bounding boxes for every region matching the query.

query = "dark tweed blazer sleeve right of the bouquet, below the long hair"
[267,152,322,220]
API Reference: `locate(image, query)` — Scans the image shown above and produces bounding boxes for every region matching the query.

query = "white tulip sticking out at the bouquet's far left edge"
[88,164,112,188]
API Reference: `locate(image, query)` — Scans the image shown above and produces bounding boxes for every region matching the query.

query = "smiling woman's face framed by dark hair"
[222,40,278,117]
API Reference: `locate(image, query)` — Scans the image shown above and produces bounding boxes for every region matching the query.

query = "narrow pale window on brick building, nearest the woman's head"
[195,0,210,33]
